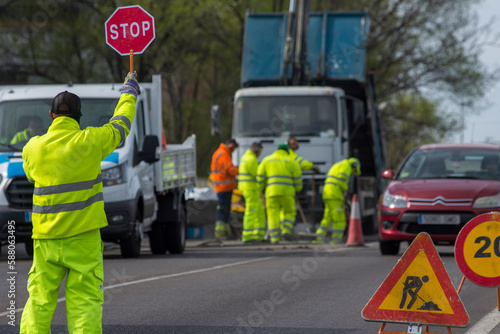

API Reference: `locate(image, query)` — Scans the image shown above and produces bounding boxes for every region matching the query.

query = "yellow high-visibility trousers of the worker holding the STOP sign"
[20,229,104,334]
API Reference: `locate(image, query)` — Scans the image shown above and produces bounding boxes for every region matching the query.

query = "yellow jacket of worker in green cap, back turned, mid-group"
[257,150,302,197]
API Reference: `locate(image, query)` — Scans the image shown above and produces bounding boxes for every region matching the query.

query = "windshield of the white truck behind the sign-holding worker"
[0,99,118,152]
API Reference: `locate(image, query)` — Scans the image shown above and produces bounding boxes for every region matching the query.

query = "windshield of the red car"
[396,149,500,180]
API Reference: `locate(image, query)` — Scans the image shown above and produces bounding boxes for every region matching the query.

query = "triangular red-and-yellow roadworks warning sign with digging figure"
[362,233,469,327]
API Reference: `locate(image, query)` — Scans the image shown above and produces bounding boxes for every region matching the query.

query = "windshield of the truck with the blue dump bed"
[233,96,339,137]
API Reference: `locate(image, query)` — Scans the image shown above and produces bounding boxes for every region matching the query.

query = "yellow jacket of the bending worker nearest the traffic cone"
[323,159,353,200]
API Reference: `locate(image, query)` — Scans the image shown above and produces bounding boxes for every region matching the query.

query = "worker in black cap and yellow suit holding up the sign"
[20,73,140,334]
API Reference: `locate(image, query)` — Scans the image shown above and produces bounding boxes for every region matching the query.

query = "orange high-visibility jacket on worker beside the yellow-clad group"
[210,144,238,193]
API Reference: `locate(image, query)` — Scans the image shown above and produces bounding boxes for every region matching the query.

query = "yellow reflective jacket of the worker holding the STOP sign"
[23,94,136,239]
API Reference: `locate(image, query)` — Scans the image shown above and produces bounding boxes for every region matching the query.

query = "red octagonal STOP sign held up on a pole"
[104,5,155,56]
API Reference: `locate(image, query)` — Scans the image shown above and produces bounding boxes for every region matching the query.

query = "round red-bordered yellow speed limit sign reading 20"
[455,212,500,287]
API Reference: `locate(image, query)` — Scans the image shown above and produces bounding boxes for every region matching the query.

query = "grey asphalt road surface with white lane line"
[0,237,500,334]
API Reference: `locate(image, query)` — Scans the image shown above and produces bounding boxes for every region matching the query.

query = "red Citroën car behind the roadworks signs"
[378,144,500,255]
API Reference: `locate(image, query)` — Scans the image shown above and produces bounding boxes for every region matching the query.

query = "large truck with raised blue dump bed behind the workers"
[212,0,385,234]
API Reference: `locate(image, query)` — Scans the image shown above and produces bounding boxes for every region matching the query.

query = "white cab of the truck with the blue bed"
[233,86,349,173]
